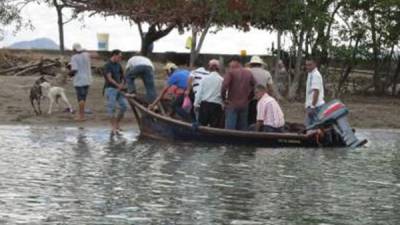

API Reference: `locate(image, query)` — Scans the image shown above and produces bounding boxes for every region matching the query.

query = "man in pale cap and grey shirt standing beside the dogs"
[70,43,92,121]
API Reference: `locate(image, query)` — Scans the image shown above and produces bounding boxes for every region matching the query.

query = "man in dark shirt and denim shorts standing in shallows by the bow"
[104,50,128,135]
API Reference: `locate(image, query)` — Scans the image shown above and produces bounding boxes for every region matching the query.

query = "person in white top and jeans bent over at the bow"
[125,55,157,102]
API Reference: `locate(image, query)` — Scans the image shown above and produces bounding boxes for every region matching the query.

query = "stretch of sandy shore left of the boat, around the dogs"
[0,76,135,127]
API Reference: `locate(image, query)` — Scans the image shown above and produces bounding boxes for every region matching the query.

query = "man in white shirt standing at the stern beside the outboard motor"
[305,59,325,127]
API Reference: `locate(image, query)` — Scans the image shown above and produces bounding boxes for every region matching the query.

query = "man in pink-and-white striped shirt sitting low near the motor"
[250,84,285,132]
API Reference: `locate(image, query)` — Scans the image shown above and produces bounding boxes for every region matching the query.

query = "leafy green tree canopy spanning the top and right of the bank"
[4,0,400,96]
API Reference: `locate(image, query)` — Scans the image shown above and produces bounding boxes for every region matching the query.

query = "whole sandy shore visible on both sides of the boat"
[0,76,400,129]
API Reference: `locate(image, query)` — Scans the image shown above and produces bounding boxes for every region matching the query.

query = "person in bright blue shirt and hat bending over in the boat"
[149,63,190,120]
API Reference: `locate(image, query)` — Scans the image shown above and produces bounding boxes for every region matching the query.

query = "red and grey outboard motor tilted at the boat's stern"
[307,100,367,148]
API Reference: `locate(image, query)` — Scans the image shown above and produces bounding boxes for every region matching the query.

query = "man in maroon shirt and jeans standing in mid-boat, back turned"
[221,56,256,130]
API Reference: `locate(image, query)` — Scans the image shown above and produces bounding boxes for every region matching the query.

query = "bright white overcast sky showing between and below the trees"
[0,4,285,55]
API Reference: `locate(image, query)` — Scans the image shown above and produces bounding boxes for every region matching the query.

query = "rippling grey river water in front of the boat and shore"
[0,126,400,225]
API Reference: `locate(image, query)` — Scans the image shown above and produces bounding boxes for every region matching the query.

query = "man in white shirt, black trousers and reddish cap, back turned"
[193,59,223,127]
